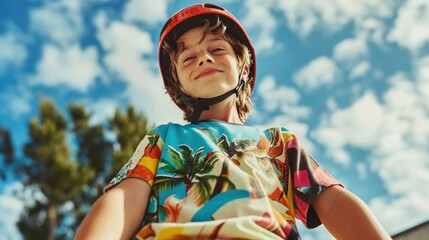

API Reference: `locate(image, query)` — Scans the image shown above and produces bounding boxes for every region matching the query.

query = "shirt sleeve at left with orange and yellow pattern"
[104,132,163,192]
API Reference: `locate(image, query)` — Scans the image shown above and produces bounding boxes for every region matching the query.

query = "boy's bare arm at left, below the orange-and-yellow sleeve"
[74,178,150,240]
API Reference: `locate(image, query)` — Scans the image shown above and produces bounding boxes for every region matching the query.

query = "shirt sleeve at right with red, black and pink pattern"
[282,129,344,228]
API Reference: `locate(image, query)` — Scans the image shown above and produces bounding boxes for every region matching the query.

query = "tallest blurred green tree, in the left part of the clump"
[18,99,94,240]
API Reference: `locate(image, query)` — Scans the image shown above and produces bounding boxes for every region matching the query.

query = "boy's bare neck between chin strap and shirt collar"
[200,94,243,124]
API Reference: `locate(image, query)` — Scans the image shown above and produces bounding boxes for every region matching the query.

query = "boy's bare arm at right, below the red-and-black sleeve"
[313,186,391,240]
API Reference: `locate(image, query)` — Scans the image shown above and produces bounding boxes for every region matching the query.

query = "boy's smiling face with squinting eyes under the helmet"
[176,27,239,98]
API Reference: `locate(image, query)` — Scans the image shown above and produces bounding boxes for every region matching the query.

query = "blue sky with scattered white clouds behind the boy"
[0,0,429,239]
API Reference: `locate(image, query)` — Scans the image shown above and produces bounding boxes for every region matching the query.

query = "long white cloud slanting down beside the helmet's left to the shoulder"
[94,12,183,123]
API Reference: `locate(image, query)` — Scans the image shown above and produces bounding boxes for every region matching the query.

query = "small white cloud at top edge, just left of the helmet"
[123,0,168,25]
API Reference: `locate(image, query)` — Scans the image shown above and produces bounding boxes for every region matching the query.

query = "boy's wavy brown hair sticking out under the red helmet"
[162,18,254,122]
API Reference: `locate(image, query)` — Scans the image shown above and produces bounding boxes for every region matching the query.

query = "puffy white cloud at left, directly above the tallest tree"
[30,44,101,92]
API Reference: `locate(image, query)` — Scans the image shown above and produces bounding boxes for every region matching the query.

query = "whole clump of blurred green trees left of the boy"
[0,99,149,239]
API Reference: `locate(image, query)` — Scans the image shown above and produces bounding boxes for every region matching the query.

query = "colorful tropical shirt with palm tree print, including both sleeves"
[106,121,341,239]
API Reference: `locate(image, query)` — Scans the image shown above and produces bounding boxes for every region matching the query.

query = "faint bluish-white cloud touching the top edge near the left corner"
[30,0,84,46]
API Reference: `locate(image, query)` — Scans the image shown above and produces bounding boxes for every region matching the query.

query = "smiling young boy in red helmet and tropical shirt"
[76,4,390,239]
